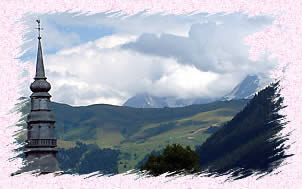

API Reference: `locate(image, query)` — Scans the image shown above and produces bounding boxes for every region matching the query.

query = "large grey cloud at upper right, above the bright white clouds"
[122,19,272,75]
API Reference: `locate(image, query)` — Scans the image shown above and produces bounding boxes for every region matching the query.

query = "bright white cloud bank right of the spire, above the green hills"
[30,33,238,105]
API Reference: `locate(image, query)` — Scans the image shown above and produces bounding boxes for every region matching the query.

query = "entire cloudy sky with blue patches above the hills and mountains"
[20,13,275,105]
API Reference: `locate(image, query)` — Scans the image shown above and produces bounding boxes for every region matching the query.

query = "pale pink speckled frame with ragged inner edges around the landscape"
[0,0,302,189]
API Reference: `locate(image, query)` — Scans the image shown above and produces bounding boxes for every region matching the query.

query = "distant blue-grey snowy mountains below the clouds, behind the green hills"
[123,75,268,108]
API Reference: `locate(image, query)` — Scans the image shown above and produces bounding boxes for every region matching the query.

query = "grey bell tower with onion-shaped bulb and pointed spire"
[24,20,60,173]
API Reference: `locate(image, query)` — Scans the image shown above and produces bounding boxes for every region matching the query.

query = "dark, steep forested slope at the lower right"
[196,83,287,179]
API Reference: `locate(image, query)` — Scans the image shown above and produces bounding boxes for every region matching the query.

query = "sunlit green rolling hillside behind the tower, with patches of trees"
[15,99,248,173]
